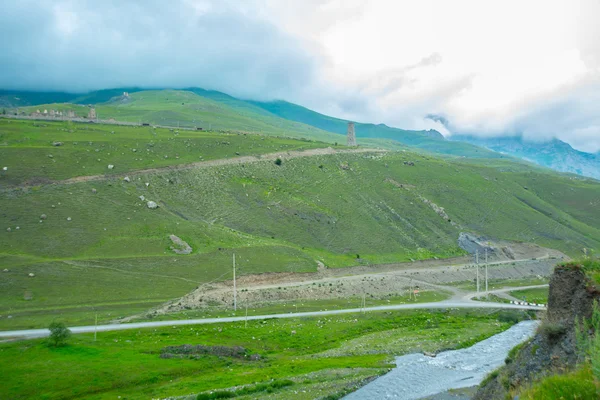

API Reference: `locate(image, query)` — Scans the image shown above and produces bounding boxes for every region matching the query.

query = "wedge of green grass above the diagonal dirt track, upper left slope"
[0,118,330,185]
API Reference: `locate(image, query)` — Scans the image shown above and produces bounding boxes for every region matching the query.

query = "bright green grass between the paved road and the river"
[0,311,510,400]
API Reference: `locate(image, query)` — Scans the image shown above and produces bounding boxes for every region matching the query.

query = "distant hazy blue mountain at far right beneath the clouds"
[451,135,600,179]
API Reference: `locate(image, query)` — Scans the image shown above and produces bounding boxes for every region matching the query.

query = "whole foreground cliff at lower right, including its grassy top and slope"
[474,258,600,400]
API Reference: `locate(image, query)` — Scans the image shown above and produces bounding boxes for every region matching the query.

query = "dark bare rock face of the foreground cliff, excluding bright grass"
[474,264,600,400]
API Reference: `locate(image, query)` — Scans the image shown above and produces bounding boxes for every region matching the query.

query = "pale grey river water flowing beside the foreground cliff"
[344,321,538,400]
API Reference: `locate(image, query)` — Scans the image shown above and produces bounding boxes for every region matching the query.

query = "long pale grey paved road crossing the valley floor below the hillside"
[0,300,545,339]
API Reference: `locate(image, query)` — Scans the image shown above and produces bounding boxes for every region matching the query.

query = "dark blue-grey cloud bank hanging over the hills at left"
[0,0,318,99]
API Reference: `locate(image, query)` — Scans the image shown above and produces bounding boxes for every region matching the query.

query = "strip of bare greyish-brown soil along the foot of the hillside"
[142,242,566,314]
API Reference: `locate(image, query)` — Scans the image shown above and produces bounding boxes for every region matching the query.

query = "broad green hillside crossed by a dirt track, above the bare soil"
[0,119,600,328]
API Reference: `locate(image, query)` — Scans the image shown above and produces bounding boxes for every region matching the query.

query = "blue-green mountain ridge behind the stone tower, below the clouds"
[7,88,505,158]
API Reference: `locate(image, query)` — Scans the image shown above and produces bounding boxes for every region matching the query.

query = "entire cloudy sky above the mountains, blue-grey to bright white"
[0,0,600,152]
